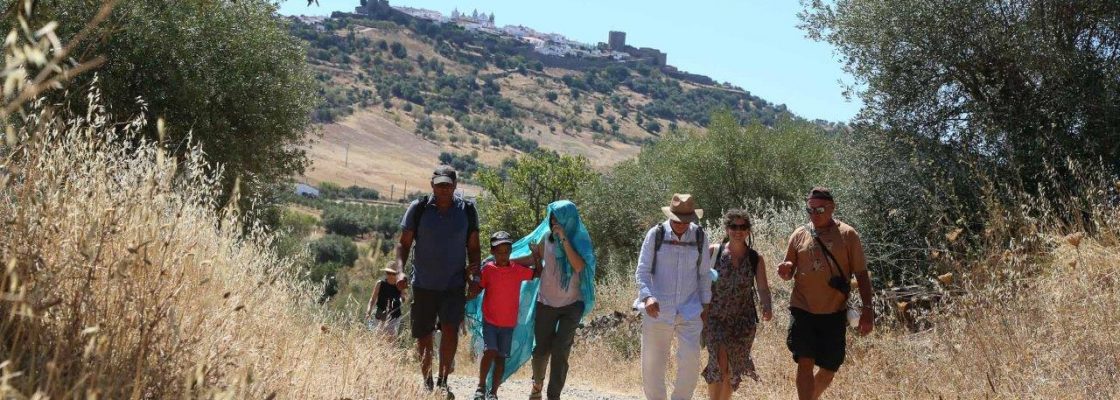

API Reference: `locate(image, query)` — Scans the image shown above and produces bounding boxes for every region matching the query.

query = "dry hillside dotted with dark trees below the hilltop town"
[291,11,795,195]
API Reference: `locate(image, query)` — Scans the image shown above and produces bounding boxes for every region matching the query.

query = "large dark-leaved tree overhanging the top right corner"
[803,0,1120,182]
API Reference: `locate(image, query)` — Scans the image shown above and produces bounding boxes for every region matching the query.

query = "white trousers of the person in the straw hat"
[642,314,703,400]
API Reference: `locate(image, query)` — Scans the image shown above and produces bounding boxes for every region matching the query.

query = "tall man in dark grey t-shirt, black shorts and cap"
[396,166,482,398]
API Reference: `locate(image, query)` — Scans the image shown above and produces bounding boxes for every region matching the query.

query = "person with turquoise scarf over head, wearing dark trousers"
[467,201,596,399]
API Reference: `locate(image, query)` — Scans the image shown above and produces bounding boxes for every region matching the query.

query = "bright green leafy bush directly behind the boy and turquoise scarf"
[478,150,596,236]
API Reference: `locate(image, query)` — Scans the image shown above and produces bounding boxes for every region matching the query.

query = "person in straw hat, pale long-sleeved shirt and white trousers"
[634,194,711,400]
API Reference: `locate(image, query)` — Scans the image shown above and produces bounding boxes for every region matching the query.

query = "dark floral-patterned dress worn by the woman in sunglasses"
[703,244,758,390]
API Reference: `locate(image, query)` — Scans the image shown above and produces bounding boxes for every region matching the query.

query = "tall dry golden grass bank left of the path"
[0,87,445,399]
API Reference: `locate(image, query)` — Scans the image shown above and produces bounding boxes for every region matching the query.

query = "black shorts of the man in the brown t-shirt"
[785,307,848,372]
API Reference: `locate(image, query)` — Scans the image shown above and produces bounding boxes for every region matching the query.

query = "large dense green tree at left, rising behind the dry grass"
[44,0,316,215]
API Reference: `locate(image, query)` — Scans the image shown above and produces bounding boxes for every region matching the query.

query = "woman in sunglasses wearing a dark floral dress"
[703,210,773,400]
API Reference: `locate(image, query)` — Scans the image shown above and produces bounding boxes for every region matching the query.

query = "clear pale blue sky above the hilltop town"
[280,0,861,121]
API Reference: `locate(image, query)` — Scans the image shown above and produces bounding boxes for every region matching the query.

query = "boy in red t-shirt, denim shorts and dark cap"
[475,231,540,400]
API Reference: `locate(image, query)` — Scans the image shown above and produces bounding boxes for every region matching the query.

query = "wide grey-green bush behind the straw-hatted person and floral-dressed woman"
[580,112,836,255]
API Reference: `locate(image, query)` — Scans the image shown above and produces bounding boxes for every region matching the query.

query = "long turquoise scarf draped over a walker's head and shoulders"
[466,201,596,381]
